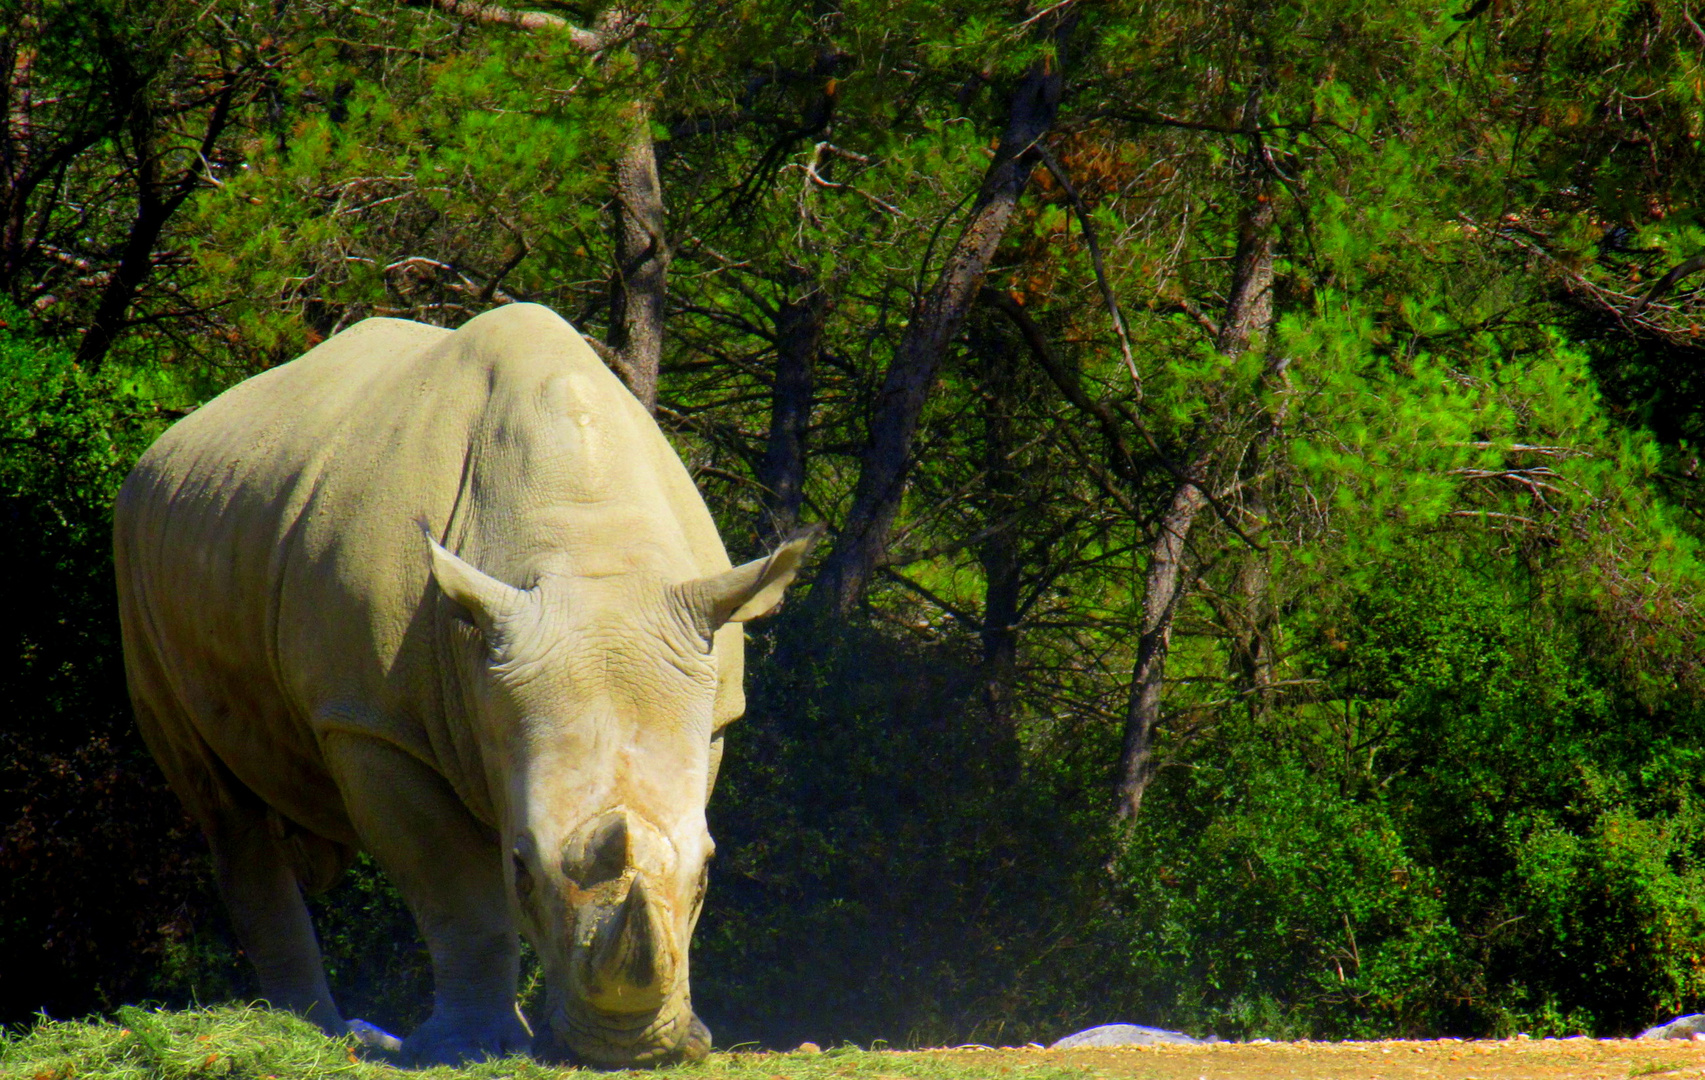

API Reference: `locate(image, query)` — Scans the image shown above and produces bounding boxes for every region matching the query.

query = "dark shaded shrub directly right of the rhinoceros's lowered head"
[694,619,1112,1046]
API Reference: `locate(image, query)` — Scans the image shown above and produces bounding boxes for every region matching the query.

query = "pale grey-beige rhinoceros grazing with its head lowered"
[114,304,815,1066]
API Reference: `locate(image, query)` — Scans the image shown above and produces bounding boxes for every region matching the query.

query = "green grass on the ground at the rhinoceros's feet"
[0,1005,1091,1080]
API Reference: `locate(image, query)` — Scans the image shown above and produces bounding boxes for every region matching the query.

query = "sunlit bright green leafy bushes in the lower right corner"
[1120,549,1705,1036]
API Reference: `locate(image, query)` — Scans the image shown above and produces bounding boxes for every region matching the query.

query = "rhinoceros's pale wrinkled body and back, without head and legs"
[114,298,740,879]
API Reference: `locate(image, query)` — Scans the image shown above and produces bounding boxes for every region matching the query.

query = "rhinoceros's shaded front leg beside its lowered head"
[324,734,532,1065]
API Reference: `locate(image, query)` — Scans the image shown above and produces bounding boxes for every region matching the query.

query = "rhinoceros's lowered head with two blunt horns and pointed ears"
[431,531,817,1066]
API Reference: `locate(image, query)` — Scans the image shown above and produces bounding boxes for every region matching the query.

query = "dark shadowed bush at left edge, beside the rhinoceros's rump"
[0,311,223,1017]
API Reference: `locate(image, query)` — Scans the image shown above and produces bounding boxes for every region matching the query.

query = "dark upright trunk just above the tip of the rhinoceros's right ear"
[757,283,829,544]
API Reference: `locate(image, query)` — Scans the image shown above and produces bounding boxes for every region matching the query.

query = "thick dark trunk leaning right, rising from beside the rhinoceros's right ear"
[812,22,1071,616]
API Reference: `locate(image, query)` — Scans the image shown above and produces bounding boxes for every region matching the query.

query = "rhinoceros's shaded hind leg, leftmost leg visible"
[206,810,344,1036]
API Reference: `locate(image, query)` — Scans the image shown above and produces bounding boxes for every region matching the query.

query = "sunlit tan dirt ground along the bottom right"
[927,1037,1705,1080]
